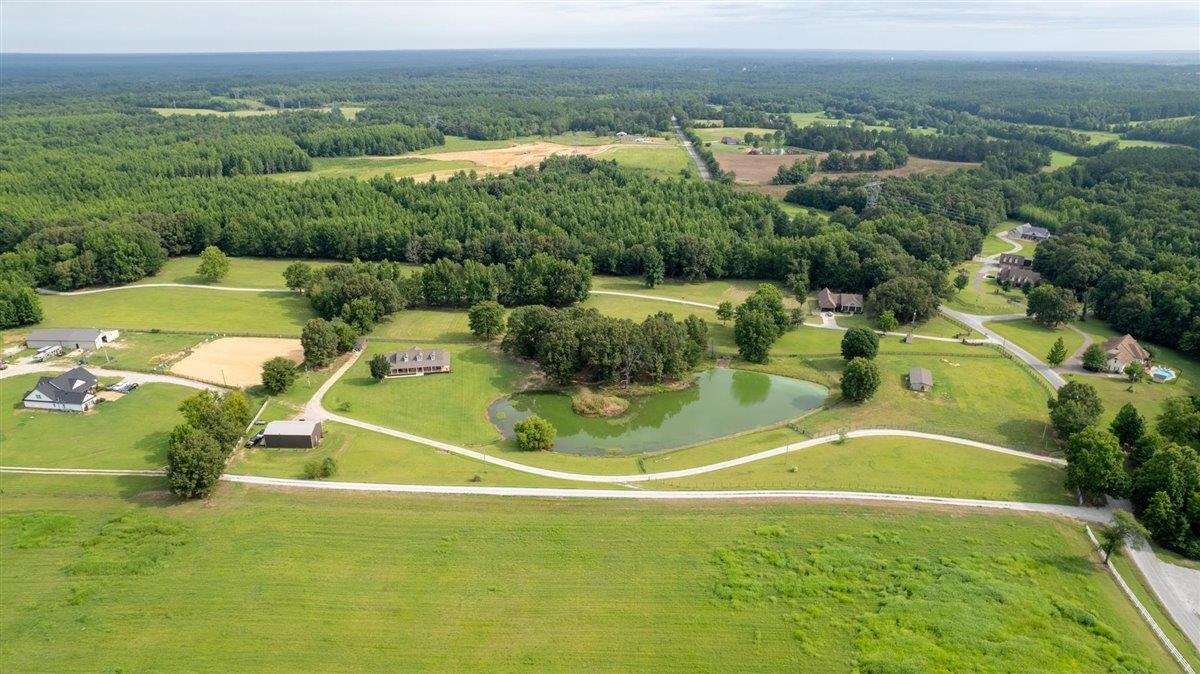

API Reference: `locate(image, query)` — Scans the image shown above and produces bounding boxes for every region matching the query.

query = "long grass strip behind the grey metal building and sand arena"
[37,288,316,336]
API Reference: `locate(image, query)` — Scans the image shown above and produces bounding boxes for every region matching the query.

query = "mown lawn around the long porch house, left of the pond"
[324,342,528,446]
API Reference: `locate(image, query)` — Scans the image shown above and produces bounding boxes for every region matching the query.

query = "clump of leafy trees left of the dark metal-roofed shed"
[167,391,253,499]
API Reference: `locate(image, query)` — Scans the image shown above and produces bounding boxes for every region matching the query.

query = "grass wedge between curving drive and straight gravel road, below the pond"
[654,438,1075,505]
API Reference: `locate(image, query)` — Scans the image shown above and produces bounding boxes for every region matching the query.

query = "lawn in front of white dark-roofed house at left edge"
[0,374,196,470]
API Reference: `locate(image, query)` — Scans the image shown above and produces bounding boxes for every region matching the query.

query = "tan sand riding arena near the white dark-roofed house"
[170,337,304,387]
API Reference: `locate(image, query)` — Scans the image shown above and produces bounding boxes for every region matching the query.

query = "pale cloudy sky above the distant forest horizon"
[7,0,1200,53]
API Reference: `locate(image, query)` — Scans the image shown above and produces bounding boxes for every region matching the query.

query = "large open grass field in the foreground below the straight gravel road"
[0,475,1175,673]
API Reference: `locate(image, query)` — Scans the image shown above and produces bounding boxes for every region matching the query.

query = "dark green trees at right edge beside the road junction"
[1049,381,1200,559]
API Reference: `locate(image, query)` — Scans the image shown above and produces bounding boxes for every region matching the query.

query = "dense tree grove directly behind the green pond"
[500,305,708,386]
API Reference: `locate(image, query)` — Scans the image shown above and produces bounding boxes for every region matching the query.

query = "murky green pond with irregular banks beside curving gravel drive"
[487,368,829,456]
